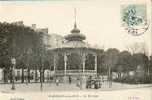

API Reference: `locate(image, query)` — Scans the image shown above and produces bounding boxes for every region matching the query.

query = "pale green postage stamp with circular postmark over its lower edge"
[121,4,149,36]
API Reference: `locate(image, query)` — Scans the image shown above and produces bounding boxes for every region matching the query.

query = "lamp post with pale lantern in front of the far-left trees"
[11,58,16,90]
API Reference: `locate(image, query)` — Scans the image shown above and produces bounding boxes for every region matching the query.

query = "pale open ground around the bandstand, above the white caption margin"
[0,82,152,93]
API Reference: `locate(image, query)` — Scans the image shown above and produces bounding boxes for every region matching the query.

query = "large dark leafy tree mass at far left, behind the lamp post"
[0,23,43,82]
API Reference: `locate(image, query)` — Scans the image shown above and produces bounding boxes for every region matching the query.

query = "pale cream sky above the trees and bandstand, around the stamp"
[0,0,152,52]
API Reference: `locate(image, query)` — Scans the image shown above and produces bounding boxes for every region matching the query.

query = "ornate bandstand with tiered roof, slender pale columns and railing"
[51,22,100,82]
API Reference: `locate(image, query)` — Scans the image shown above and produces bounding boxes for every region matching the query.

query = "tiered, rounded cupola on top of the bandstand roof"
[65,23,86,41]
